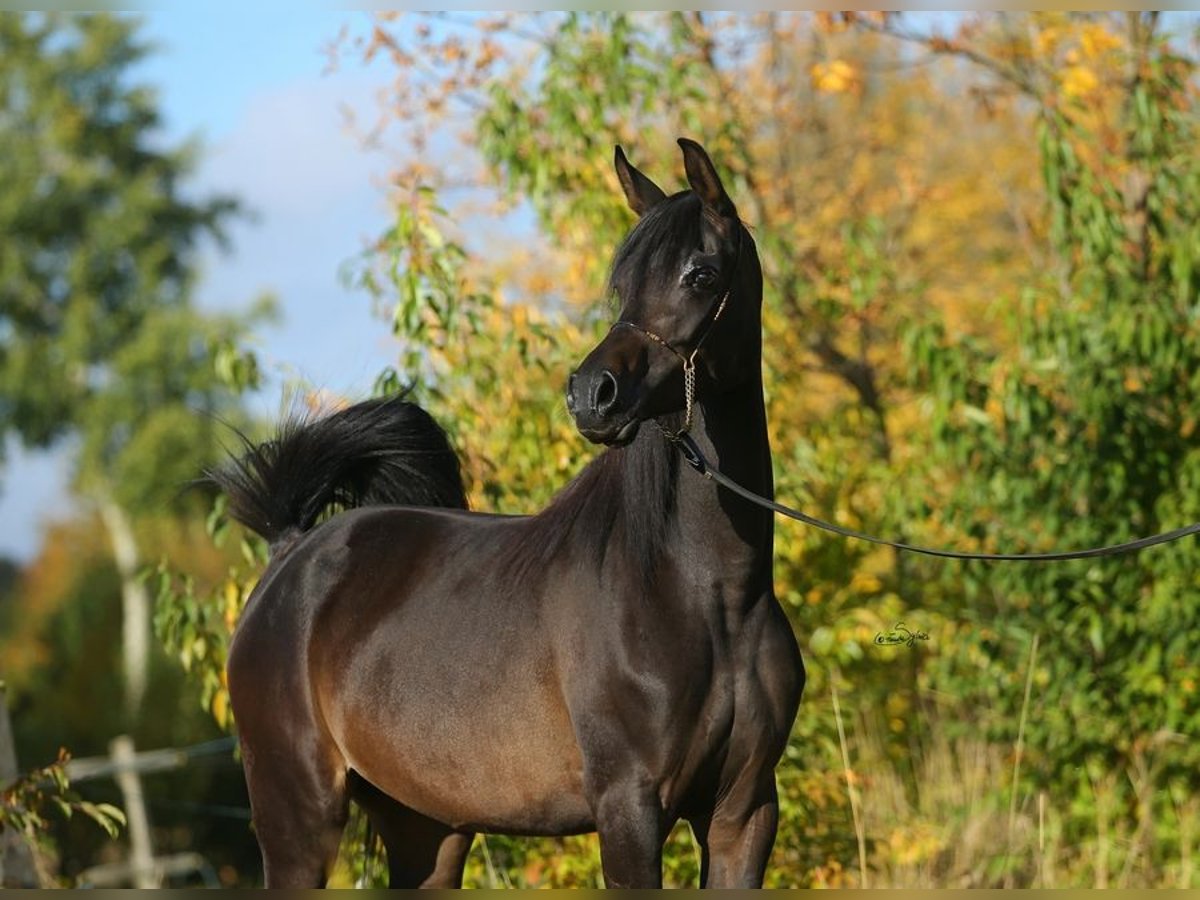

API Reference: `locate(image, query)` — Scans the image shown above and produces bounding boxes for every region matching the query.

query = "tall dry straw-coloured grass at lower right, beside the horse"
[830,691,1200,889]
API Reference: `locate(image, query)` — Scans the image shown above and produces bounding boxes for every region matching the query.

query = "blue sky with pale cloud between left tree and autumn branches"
[0,12,403,559]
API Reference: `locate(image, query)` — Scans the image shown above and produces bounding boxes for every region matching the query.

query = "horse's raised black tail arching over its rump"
[205,396,467,554]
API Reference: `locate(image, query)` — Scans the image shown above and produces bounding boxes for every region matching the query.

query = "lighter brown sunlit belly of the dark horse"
[319,643,592,834]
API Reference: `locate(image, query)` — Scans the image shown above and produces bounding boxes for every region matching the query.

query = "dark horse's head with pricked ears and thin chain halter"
[566,138,762,445]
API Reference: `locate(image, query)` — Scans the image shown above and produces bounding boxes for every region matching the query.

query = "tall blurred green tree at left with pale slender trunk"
[0,13,260,715]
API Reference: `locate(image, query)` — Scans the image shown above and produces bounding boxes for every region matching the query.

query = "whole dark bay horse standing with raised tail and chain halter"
[212,139,804,887]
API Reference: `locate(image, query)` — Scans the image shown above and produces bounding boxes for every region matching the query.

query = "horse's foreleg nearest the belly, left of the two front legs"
[595,787,666,888]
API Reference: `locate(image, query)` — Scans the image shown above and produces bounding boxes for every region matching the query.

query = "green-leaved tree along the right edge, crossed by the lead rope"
[883,13,1200,886]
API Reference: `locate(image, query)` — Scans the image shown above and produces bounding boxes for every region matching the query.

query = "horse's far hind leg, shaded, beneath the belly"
[352,776,475,888]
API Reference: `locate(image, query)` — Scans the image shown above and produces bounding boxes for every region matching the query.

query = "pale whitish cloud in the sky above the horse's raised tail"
[194,69,396,409]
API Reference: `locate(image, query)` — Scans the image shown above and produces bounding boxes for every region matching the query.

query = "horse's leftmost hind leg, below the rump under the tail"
[241,734,349,888]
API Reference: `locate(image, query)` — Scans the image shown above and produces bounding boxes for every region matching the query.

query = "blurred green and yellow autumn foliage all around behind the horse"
[0,7,1200,888]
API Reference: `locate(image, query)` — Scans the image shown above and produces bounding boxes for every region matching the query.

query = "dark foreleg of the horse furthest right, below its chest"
[697,778,779,888]
